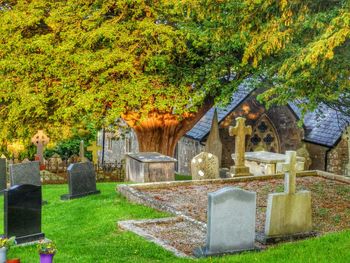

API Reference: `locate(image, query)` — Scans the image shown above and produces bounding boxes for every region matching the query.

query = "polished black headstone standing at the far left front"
[4,184,44,244]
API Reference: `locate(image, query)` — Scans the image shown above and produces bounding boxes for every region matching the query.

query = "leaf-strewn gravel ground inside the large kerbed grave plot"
[138,176,350,233]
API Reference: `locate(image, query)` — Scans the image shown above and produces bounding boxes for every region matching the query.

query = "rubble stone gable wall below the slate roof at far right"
[327,139,349,175]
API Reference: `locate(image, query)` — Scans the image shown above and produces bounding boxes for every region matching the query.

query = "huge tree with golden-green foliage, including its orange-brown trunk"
[0,0,350,154]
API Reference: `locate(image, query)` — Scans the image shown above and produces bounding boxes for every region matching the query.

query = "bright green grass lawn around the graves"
[3,183,350,263]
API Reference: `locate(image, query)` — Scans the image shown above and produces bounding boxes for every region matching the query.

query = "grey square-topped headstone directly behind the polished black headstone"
[10,161,41,186]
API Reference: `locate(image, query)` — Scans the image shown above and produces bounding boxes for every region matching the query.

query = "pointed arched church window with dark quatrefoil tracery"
[247,114,280,152]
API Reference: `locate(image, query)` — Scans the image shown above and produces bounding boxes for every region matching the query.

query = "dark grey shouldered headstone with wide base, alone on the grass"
[61,162,101,200]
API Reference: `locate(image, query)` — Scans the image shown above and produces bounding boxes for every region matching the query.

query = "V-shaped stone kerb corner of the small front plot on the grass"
[117,217,193,258]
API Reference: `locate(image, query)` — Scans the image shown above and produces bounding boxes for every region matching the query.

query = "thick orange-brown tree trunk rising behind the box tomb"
[122,99,213,157]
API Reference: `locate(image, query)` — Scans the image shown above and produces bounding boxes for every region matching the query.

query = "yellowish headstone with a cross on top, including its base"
[259,151,314,243]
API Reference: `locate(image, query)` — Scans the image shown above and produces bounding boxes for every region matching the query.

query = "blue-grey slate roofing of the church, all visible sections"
[186,89,350,147]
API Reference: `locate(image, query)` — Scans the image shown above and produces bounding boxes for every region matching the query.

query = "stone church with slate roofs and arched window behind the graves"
[98,85,350,175]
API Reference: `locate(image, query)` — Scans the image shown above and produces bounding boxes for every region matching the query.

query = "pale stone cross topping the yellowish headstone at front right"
[282,151,297,194]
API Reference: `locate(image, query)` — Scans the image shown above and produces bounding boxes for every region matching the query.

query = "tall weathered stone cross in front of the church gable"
[229,117,252,176]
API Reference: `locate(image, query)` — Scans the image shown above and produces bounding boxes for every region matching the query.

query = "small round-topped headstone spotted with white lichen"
[191,152,220,180]
